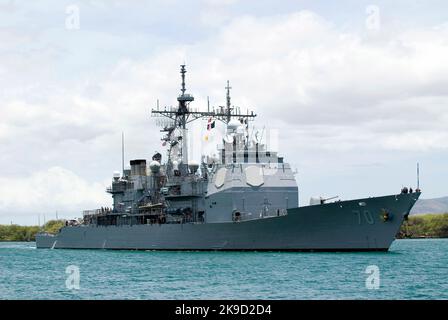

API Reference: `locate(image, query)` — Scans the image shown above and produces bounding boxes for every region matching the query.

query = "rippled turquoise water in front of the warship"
[0,239,448,299]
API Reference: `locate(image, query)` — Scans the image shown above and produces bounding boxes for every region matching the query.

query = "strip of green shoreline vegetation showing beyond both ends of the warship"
[0,213,448,242]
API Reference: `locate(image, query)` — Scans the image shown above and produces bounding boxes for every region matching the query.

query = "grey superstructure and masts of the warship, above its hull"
[84,65,298,225]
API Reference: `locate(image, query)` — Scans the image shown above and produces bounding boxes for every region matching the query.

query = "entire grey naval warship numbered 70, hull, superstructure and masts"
[36,65,421,251]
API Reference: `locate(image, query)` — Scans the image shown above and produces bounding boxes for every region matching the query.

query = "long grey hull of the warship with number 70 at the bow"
[36,193,420,251]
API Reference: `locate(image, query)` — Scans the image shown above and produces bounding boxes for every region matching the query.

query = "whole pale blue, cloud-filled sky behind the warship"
[0,0,448,225]
